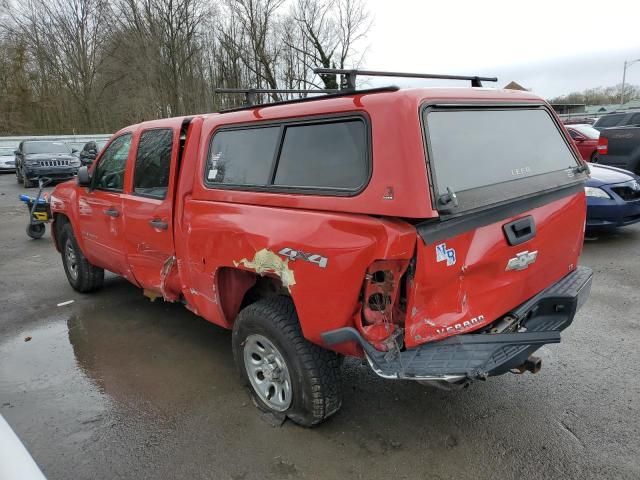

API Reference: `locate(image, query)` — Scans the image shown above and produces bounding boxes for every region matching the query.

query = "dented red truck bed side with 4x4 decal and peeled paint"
[176,199,416,354]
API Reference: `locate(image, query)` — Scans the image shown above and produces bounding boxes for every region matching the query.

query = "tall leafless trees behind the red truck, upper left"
[0,0,371,135]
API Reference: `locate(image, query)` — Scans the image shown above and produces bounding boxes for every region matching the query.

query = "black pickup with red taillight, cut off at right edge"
[594,127,640,175]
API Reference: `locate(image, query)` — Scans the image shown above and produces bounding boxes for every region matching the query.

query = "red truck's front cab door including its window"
[77,133,131,279]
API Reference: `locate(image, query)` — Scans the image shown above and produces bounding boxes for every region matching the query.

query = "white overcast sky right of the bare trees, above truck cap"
[361,0,640,98]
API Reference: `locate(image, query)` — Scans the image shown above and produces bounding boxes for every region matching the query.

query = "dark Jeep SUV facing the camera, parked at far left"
[15,140,80,188]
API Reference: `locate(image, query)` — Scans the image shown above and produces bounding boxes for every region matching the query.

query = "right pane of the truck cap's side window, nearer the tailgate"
[274,120,367,190]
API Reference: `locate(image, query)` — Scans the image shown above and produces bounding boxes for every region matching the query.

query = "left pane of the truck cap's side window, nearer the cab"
[206,127,280,186]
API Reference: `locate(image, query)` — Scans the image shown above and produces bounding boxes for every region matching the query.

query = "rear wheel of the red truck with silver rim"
[232,296,342,427]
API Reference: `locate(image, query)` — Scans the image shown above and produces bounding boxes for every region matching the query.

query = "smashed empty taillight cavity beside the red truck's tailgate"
[356,260,409,350]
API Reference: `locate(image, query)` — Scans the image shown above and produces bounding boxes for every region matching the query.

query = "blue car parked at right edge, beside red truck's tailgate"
[585,165,640,230]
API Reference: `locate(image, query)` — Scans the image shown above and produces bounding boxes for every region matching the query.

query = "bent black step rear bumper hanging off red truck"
[322,267,592,382]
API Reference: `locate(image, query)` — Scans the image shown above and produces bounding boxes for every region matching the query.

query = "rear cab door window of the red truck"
[133,129,173,198]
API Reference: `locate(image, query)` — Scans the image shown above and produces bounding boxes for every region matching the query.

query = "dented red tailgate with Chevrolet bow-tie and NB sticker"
[405,187,586,348]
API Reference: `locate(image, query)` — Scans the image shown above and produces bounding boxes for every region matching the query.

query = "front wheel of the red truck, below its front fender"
[60,223,104,293]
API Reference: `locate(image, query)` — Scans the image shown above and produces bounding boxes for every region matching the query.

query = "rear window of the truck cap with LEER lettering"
[424,108,578,213]
